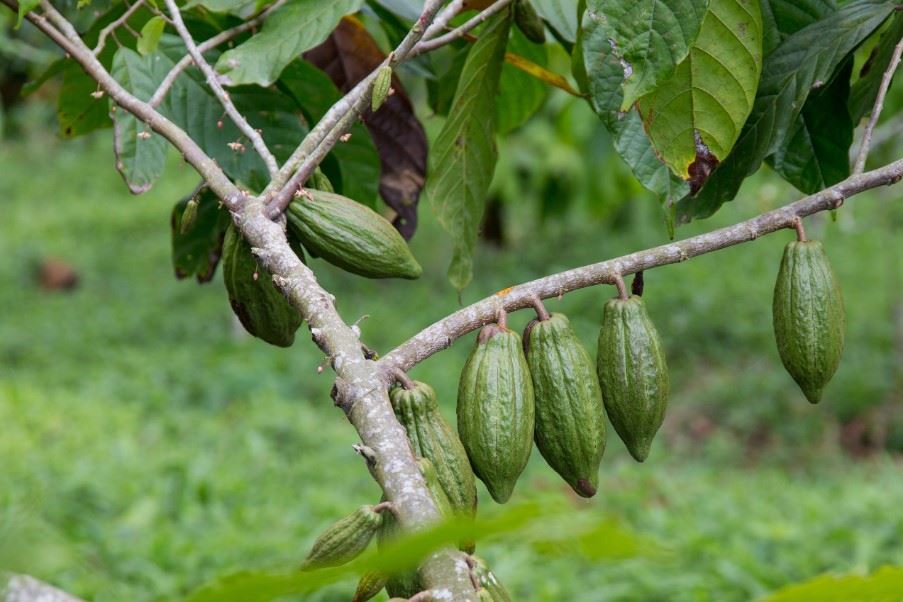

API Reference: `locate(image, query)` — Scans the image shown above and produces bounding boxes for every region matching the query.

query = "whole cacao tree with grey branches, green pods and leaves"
[2,0,903,600]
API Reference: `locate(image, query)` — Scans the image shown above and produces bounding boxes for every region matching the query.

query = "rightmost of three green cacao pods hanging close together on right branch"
[596,296,670,462]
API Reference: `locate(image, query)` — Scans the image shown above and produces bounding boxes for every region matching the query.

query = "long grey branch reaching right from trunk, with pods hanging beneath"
[378,159,903,372]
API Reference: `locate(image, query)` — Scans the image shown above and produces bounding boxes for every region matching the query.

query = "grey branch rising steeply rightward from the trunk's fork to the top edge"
[264,0,443,217]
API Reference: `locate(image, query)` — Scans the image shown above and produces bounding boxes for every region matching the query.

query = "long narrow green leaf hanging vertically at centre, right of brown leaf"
[426,10,511,290]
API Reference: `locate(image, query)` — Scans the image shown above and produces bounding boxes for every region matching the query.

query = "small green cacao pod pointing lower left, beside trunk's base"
[301,506,383,570]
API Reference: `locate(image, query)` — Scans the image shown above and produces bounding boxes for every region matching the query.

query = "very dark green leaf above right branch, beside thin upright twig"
[770,61,853,194]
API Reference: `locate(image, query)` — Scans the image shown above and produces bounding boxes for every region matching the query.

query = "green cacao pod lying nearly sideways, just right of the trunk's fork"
[286,188,423,279]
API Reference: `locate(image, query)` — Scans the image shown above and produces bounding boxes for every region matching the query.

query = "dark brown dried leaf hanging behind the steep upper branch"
[304,17,427,240]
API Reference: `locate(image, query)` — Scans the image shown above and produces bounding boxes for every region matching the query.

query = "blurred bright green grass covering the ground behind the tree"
[0,118,903,601]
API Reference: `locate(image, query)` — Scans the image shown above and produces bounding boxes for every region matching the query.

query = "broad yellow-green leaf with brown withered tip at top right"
[637,0,762,183]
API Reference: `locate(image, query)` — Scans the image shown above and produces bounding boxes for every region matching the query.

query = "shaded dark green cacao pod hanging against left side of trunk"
[223,224,301,347]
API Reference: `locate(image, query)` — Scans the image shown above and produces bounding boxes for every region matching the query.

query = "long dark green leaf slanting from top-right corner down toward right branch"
[678,0,895,222]
